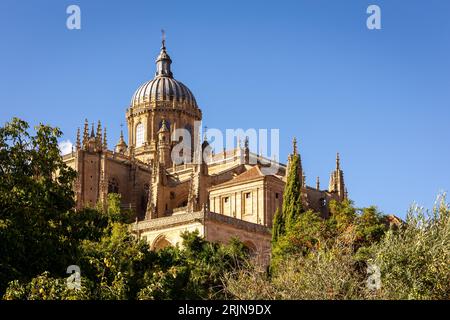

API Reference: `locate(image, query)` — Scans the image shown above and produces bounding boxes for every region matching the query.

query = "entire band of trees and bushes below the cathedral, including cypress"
[0,119,450,300]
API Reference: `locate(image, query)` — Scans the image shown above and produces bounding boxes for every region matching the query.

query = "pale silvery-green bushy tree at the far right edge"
[371,196,450,300]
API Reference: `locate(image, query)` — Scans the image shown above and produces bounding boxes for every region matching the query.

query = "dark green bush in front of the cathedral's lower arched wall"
[138,232,248,300]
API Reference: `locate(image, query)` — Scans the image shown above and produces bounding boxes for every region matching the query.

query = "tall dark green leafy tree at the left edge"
[0,118,76,292]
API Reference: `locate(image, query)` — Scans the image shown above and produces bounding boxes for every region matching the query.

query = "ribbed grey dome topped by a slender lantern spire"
[131,41,198,112]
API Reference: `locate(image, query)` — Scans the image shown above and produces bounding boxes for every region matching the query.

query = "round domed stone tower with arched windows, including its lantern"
[126,33,202,165]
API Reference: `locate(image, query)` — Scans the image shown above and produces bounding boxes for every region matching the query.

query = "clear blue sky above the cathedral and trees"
[0,0,450,217]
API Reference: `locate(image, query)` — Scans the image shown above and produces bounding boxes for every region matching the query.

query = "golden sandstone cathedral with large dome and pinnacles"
[63,40,347,264]
